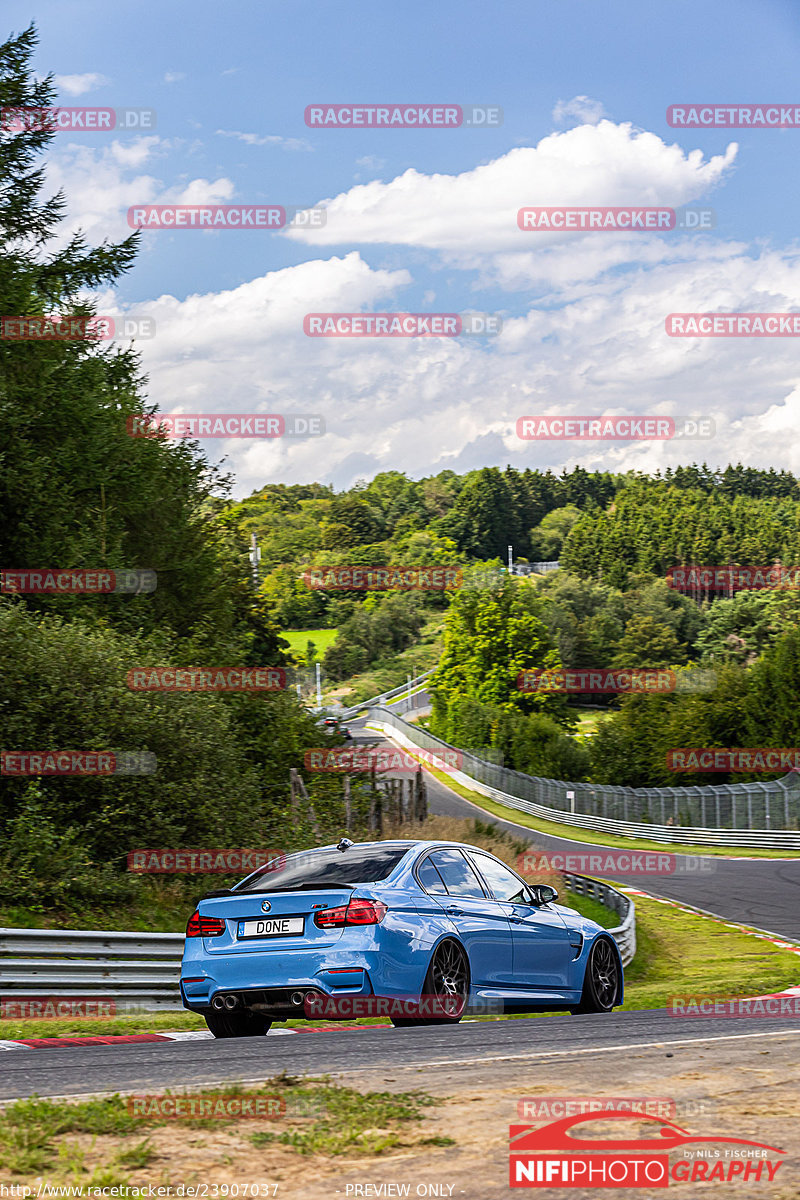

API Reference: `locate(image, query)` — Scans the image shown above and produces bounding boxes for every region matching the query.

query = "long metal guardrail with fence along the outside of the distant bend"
[367,707,800,850]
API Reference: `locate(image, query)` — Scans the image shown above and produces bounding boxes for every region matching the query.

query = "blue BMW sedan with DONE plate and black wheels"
[181,838,622,1038]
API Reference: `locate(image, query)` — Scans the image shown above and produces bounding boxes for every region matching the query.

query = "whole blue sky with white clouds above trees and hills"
[5,0,800,492]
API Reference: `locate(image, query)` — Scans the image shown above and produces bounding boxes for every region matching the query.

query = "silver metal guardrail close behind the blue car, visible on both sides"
[0,875,636,1013]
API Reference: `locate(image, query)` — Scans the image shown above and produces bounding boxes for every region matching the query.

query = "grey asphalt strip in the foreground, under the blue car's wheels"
[0,1009,800,1100]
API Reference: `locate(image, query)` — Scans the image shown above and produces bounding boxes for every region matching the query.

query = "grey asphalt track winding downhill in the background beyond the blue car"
[350,721,800,942]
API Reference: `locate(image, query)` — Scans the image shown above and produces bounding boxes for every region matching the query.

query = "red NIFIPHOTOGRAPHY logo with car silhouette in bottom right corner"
[509,1108,786,1188]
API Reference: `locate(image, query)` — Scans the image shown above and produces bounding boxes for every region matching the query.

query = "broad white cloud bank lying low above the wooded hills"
[120,246,800,494]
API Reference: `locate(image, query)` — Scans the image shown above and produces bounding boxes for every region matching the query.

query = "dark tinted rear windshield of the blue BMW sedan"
[235,845,410,892]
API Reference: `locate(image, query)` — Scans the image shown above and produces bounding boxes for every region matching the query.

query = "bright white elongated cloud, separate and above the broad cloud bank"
[284,121,738,275]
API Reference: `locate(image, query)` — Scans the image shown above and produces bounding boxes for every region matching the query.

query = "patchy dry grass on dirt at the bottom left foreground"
[0,1075,441,1180]
